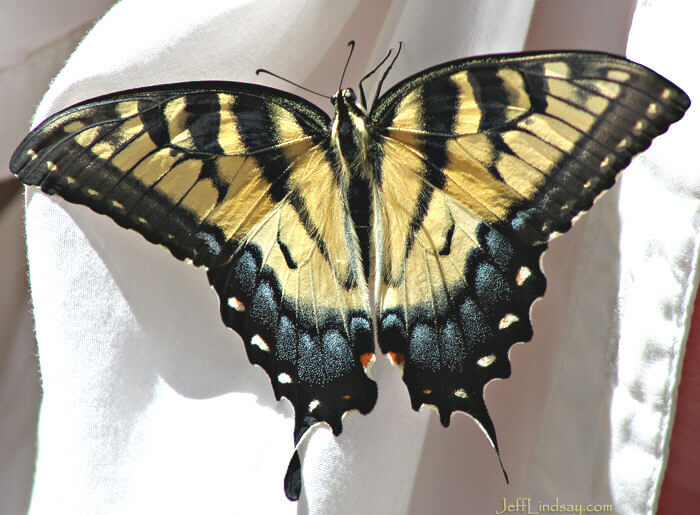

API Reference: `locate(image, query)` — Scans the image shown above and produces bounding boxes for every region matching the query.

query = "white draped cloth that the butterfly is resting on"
[9,0,699,514]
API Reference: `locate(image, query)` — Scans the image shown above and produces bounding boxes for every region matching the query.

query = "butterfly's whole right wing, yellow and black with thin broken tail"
[370,52,689,456]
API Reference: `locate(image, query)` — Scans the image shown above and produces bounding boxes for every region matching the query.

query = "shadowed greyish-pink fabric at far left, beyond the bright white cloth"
[0,0,111,515]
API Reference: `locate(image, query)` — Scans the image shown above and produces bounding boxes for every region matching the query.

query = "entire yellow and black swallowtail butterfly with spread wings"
[10,42,690,500]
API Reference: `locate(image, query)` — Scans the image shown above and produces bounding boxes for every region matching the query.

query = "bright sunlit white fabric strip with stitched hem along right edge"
[610,0,700,513]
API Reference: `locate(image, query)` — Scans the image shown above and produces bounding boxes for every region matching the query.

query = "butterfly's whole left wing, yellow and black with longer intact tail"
[11,83,377,497]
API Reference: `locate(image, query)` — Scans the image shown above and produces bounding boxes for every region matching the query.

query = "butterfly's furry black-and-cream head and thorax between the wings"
[331,88,371,181]
